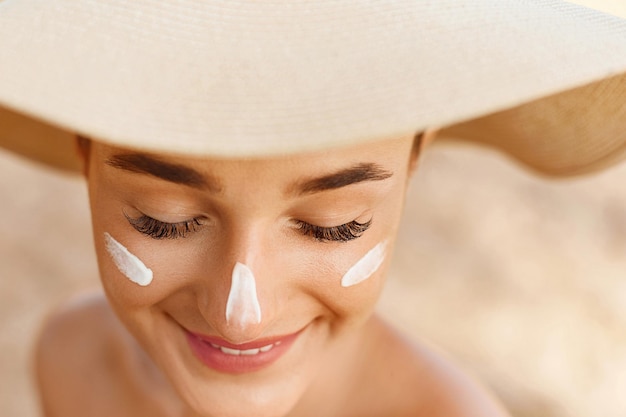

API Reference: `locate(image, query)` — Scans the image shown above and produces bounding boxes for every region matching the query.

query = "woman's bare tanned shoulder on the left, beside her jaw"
[35,292,177,417]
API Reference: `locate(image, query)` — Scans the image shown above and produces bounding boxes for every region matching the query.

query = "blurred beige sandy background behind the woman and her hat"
[0,141,626,417]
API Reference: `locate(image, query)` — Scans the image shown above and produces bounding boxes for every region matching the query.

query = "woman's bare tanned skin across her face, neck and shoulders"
[36,132,506,417]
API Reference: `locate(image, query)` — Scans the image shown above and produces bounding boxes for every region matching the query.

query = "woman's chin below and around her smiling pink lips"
[150,316,325,417]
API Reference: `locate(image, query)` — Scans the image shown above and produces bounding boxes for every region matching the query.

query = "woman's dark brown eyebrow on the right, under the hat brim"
[292,163,393,194]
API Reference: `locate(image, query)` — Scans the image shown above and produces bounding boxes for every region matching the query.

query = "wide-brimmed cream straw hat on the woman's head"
[0,0,626,175]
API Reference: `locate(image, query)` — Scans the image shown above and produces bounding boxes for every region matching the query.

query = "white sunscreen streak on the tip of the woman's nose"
[226,262,261,327]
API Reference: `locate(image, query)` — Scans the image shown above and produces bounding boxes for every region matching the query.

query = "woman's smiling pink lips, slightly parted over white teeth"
[186,330,302,374]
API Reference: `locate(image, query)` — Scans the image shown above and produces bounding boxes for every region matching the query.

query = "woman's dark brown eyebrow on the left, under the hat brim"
[105,153,221,192]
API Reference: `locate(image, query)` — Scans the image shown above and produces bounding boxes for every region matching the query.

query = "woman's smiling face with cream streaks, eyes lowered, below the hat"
[87,138,413,416]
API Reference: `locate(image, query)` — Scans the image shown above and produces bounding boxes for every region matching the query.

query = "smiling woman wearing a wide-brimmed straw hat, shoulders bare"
[0,0,626,416]
